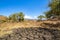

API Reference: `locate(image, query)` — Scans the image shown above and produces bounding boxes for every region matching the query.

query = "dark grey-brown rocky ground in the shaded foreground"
[0,28,60,40]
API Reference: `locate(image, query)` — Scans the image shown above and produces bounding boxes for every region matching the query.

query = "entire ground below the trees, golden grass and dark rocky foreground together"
[0,20,60,40]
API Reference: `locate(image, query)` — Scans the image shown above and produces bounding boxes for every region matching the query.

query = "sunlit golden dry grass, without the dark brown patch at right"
[0,21,60,36]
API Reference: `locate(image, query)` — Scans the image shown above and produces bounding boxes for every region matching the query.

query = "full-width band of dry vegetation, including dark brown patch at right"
[0,20,60,36]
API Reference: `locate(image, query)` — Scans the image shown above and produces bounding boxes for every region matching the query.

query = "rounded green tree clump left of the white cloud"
[9,12,24,22]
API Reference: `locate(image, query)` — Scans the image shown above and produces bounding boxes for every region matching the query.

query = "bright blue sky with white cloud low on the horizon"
[0,0,49,18]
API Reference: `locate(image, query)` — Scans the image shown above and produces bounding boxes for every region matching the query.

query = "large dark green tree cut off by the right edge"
[45,0,60,19]
